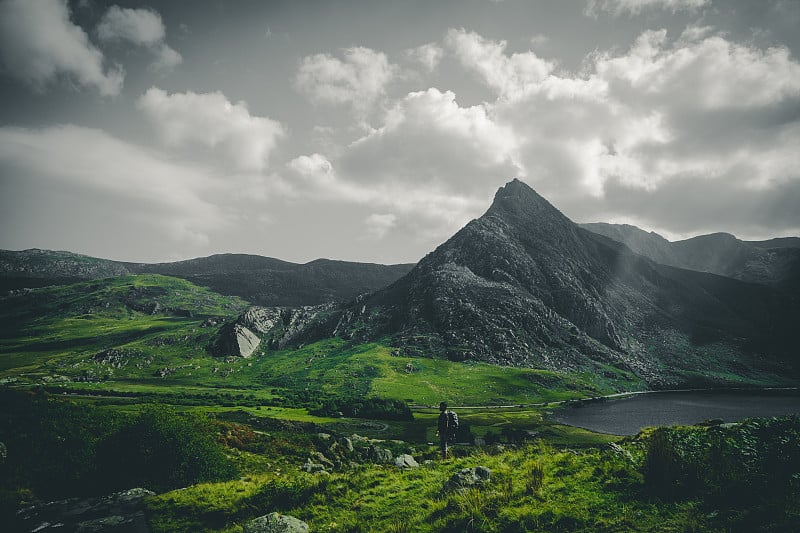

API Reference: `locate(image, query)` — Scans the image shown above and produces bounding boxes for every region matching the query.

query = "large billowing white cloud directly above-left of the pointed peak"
[287,88,520,241]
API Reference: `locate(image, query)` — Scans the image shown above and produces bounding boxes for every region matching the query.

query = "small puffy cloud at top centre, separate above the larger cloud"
[295,46,397,111]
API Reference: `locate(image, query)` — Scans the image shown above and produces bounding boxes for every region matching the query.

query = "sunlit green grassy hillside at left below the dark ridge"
[0,275,247,376]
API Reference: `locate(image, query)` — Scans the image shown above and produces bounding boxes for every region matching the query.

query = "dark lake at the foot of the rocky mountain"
[552,391,800,435]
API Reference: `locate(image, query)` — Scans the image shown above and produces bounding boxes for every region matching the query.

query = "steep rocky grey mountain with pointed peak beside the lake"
[272,180,800,386]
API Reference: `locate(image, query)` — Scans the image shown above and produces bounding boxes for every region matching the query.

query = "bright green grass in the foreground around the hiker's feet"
[142,438,696,532]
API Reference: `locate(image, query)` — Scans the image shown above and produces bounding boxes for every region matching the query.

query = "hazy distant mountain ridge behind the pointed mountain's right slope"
[581,223,800,291]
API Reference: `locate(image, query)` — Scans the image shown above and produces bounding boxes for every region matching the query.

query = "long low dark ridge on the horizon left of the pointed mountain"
[0,249,413,306]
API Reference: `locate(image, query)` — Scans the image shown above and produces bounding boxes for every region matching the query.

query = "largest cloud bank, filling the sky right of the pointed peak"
[448,27,800,235]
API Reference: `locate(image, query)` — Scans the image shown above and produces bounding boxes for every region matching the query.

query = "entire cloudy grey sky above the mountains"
[0,0,800,263]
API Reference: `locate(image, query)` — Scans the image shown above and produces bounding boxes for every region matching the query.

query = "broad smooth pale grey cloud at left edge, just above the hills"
[0,126,230,257]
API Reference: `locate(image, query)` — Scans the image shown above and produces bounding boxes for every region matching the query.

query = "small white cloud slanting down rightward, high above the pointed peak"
[444,28,555,98]
